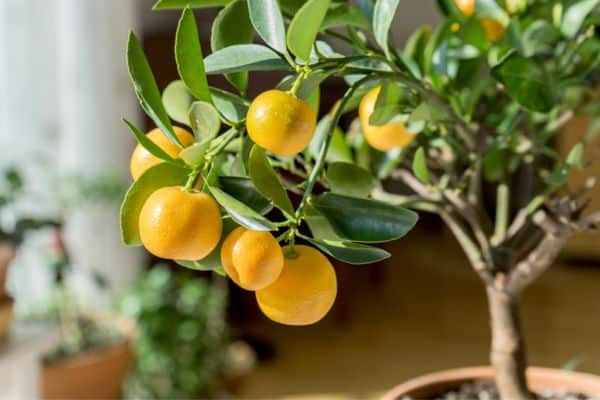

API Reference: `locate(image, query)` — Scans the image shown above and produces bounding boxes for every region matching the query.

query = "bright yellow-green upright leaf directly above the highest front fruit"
[287,0,330,61]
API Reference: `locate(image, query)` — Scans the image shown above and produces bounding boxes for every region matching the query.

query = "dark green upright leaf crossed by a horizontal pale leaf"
[210,0,254,94]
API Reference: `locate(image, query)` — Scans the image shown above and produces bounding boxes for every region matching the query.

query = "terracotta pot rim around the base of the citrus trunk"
[382,367,600,400]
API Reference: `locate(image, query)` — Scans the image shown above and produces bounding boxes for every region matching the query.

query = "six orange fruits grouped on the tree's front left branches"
[130,88,414,325]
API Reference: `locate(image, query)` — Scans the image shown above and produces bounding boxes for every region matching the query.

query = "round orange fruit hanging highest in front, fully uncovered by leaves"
[246,90,317,156]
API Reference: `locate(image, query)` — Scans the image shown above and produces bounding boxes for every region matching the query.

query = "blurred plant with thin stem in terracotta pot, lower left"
[41,229,133,399]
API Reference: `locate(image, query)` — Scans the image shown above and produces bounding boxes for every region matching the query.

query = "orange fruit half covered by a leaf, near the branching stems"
[358,87,415,151]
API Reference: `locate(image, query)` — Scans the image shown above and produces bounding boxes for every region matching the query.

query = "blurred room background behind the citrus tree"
[0,0,600,399]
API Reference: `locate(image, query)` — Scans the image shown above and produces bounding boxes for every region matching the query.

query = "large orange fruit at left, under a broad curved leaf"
[139,186,223,261]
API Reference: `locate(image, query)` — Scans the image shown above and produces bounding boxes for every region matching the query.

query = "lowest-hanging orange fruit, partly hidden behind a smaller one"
[256,245,337,325]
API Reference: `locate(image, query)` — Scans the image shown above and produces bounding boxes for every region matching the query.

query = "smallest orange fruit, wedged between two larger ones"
[221,227,283,290]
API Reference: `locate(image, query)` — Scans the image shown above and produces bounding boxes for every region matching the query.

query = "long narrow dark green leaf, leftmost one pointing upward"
[127,32,181,146]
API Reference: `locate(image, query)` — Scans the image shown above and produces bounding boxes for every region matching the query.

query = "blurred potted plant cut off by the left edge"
[0,168,58,338]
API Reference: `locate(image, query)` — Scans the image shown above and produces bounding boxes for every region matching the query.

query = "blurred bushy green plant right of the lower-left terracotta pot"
[121,265,253,399]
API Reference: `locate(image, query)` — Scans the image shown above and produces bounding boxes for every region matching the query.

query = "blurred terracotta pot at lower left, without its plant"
[41,340,133,399]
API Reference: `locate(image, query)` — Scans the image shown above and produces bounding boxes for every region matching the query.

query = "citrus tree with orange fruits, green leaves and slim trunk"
[121,0,600,399]
